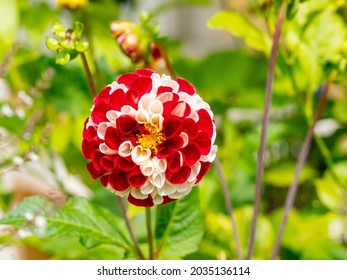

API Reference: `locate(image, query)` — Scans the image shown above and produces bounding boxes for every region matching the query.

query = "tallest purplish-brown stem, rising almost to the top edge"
[247,4,286,259]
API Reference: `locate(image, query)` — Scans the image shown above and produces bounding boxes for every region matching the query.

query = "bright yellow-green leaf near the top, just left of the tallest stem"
[207,11,271,53]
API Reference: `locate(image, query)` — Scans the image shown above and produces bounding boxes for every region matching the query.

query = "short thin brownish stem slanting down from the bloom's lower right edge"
[214,157,243,260]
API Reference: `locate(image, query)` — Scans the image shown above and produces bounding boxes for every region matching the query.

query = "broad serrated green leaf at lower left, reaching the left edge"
[0,196,131,251]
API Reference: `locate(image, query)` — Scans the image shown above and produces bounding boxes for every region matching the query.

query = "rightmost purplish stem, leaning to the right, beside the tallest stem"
[271,75,334,260]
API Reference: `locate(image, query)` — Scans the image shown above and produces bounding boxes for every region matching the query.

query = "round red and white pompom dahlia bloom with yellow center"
[82,69,217,207]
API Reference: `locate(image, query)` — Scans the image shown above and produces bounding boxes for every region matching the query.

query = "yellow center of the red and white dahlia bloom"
[136,124,165,153]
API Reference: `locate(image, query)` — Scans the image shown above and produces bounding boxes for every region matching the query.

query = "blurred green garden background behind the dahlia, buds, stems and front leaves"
[0,0,347,259]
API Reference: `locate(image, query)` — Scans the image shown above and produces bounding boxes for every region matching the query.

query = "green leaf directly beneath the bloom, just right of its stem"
[155,187,203,259]
